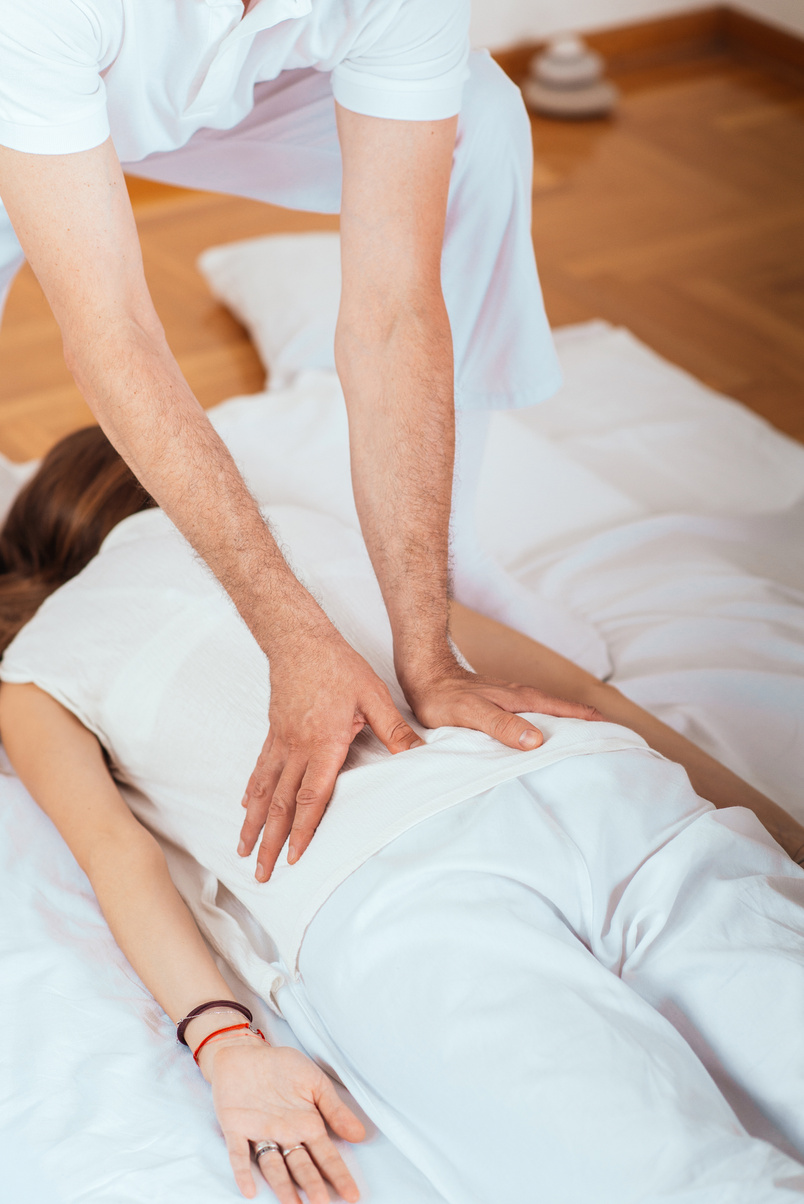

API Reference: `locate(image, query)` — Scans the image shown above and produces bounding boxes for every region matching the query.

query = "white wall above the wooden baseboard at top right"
[472,0,804,49]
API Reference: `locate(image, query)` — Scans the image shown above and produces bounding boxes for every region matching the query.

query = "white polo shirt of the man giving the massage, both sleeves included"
[0,0,469,163]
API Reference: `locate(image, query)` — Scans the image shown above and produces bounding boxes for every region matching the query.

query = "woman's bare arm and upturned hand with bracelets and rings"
[0,683,363,1204]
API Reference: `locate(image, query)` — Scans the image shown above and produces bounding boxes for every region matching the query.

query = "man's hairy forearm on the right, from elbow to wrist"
[336,294,455,678]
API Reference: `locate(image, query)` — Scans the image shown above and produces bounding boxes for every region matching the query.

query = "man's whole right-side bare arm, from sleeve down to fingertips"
[336,106,587,748]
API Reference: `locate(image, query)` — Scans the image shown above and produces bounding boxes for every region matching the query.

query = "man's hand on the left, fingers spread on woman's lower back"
[238,627,422,881]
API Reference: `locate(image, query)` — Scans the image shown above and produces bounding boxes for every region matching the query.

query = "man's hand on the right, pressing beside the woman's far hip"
[403,657,603,749]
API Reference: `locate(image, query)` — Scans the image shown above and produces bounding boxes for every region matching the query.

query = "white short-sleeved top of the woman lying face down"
[0,507,645,998]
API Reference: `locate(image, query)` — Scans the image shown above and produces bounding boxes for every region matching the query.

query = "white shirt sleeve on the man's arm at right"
[332,0,471,122]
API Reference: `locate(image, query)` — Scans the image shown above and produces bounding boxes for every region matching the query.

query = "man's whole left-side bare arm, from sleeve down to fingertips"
[0,141,416,878]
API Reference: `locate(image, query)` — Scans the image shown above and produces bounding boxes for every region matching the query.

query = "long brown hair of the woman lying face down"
[0,426,156,655]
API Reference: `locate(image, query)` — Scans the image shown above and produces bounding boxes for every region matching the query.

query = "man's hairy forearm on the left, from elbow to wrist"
[67,323,326,653]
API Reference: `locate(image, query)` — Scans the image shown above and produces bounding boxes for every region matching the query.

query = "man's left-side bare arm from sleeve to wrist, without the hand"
[0,141,314,648]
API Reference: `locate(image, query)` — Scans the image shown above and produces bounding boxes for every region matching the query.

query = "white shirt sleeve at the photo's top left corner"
[0,0,110,154]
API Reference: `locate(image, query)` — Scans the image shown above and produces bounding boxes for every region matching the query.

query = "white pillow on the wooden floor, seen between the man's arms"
[199,232,341,389]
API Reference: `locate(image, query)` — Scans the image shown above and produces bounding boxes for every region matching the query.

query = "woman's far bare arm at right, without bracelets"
[451,602,804,864]
